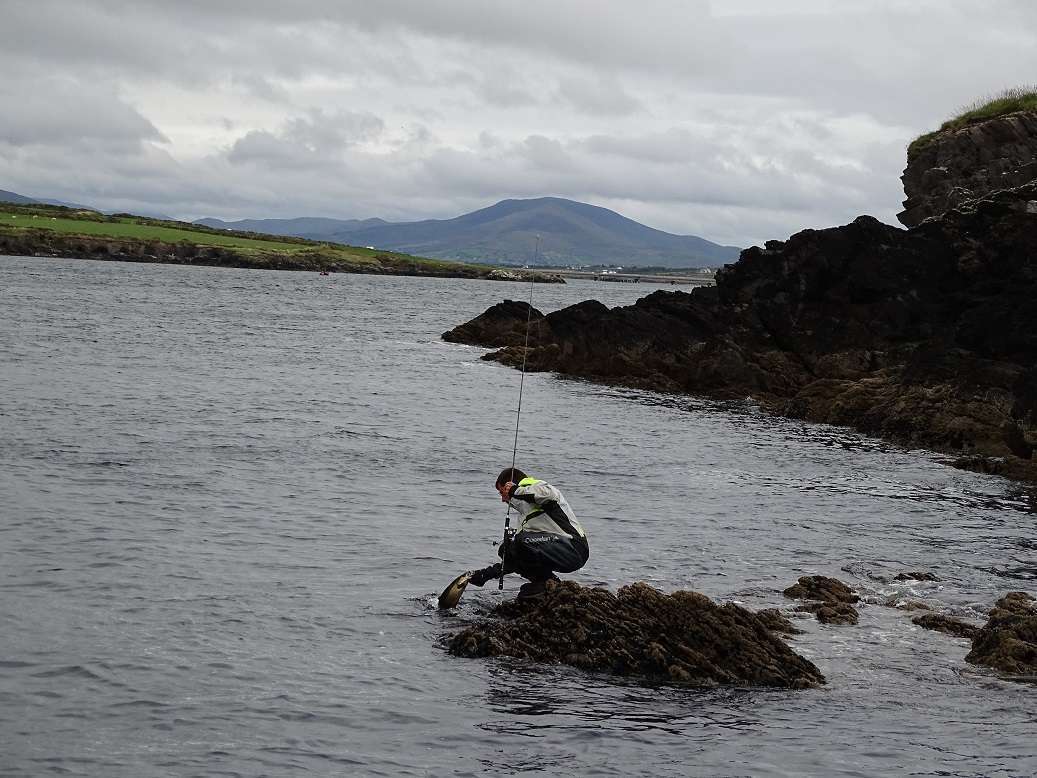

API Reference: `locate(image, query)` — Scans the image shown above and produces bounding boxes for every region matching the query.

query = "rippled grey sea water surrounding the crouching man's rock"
[0,257,1037,778]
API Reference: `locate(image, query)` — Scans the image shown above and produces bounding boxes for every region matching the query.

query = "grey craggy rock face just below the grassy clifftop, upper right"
[897,111,1037,227]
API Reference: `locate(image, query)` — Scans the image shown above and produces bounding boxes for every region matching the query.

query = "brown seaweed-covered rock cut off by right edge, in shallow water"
[965,591,1037,675]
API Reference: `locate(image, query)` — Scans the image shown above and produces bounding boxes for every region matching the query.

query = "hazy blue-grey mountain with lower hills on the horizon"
[195,197,740,268]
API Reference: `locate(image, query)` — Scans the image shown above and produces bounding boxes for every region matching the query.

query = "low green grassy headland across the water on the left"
[0,203,491,278]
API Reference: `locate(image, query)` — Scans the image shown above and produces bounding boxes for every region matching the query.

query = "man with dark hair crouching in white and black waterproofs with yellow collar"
[469,468,590,599]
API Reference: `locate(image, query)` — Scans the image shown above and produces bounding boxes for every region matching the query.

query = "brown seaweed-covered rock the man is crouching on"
[449,581,824,689]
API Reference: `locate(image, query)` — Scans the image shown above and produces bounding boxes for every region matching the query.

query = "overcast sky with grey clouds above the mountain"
[0,0,1037,246]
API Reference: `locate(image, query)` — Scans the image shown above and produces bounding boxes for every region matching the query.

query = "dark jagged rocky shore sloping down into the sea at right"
[443,113,1037,481]
